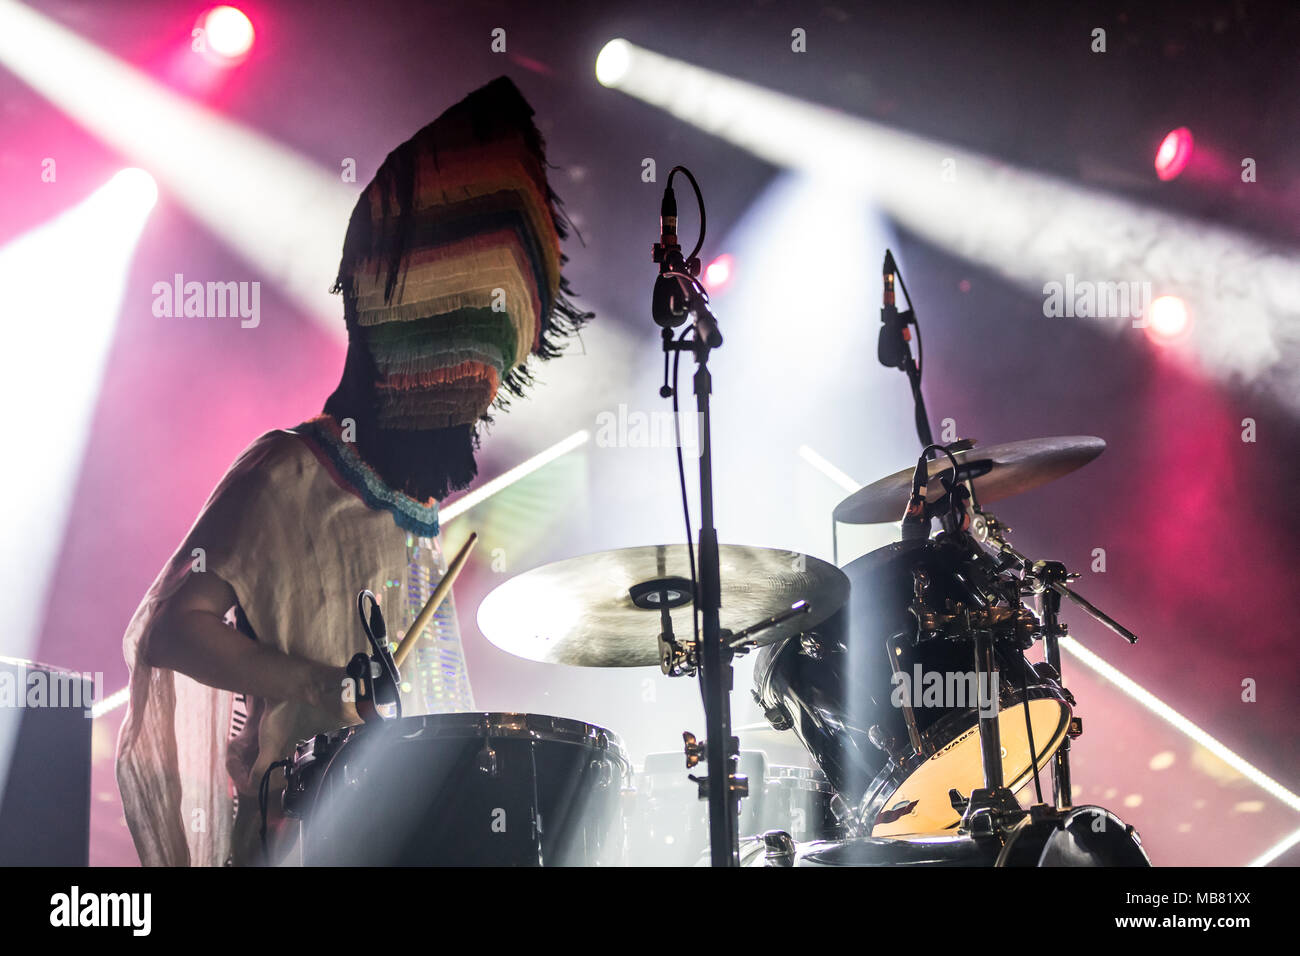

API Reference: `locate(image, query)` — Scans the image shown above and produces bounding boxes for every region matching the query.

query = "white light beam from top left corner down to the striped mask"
[0,0,359,327]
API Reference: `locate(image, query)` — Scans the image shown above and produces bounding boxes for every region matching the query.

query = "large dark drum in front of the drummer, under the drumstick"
[283,713,631,866]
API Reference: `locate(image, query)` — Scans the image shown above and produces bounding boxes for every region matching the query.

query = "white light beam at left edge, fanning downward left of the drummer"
[0,169,157,658]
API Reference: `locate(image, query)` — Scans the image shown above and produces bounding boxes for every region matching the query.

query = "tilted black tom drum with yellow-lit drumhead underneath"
[754,541,1073,836]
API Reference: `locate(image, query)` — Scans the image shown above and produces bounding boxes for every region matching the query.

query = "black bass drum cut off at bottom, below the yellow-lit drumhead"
[741,806,1151,868]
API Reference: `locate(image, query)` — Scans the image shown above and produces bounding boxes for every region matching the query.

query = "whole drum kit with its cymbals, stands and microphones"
[283,184,1149,866]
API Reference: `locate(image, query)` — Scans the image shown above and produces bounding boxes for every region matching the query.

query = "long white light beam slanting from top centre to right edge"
[607,40,1300,421]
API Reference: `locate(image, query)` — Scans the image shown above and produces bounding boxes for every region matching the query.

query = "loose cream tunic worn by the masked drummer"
[117,431,473,866]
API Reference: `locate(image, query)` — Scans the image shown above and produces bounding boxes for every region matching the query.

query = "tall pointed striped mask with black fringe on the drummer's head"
[326,77,590,498]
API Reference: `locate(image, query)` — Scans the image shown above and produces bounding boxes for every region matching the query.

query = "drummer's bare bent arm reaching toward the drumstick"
[146,572,360,723]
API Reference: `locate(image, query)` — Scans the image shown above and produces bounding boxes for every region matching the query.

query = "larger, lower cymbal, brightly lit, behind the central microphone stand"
[478,544,849,667]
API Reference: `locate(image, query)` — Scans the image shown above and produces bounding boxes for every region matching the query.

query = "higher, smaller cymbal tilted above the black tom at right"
[835,434,1106,524]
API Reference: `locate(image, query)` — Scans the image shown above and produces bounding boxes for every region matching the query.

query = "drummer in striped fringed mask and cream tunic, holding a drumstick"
[117,77,590,865]
